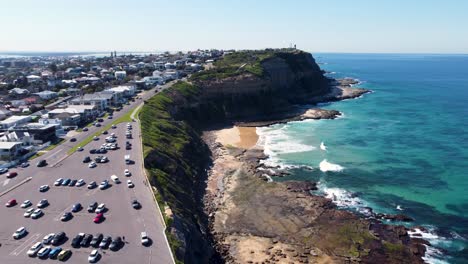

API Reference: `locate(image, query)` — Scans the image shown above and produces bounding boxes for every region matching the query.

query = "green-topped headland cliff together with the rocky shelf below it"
[140,50,424,263]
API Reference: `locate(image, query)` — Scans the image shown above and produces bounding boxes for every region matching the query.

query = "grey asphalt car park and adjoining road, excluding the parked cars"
[0,86,173,264]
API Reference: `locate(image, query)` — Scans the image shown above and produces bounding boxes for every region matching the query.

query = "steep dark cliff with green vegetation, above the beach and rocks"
[140,51,330,263]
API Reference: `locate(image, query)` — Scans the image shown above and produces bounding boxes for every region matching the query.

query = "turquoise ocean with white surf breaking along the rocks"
[257,54,468,263]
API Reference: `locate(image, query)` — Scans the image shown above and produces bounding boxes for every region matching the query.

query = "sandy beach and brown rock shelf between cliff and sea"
[203,80,428,263]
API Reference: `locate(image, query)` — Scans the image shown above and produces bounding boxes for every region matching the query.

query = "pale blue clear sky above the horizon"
[0,0,468,54]
